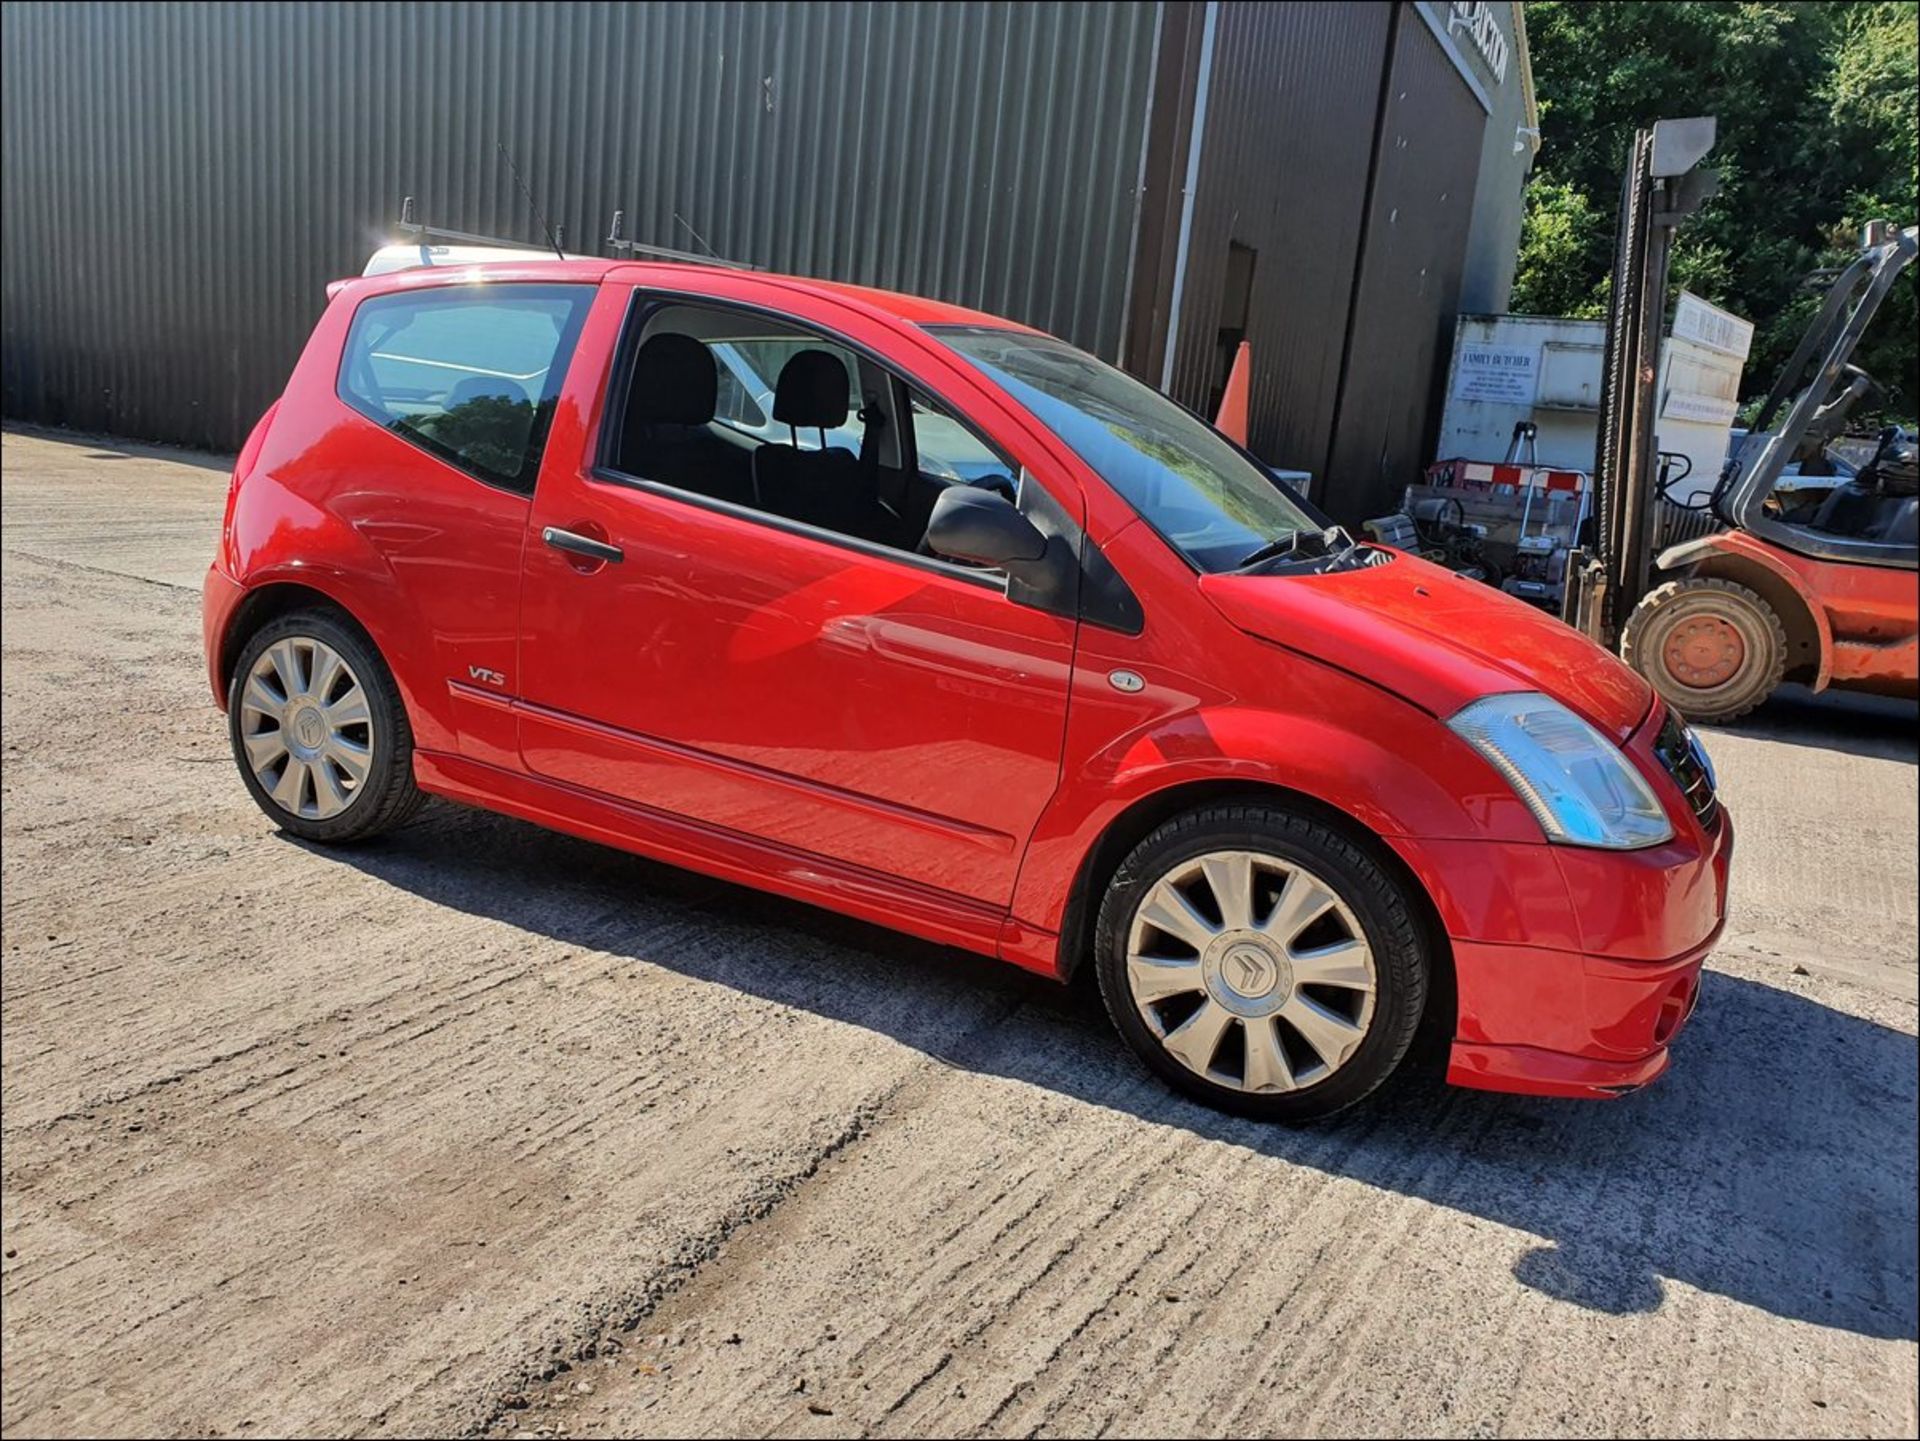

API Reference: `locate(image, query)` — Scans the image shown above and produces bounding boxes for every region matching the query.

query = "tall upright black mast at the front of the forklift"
[1563,115,1718,650]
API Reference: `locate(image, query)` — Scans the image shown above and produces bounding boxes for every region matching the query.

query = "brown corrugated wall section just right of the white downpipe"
[1150,2,1394,476]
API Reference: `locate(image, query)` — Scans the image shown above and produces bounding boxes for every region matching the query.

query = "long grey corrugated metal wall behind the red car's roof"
[0,2,1160,449]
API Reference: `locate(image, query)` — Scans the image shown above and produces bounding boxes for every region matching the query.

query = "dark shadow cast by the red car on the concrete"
[307,804,1920,1341]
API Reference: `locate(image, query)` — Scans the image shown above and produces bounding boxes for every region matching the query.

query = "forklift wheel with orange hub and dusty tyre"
[1620,579,1788,723]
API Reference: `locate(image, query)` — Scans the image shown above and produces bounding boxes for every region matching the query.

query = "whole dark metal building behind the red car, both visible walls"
[0,0,1536,520]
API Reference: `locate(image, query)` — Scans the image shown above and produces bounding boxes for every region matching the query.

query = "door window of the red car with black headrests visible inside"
[607,303,1018,566]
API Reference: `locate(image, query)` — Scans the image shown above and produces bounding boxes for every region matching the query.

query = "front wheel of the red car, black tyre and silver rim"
[1096,804,1430,1121]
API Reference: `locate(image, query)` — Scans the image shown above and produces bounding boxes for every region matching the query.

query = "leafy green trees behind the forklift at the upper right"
[1513,0,1920,418]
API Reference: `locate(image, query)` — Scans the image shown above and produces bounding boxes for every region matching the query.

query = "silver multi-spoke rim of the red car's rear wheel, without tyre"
[240,635,372,821]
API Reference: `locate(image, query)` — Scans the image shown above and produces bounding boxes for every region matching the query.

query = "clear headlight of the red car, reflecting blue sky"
[1448,693,1674,850]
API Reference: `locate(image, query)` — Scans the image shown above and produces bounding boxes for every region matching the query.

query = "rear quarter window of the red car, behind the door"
[338,284,593,495]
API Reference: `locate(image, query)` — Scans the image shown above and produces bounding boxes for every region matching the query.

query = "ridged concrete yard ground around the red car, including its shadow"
[0,434,1920,1437]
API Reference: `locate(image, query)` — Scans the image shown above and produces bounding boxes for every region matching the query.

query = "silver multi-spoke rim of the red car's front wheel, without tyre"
[1127,850,1377,1092]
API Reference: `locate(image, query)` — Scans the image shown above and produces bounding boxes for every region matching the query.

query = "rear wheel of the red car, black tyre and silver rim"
[227,610,424,846]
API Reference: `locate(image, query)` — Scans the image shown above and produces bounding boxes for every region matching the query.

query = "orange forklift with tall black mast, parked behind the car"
[1563,119,1920,721]
